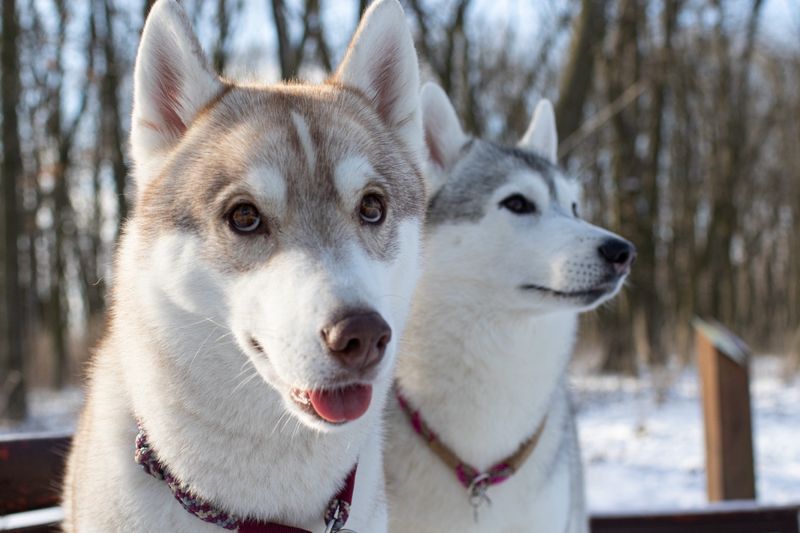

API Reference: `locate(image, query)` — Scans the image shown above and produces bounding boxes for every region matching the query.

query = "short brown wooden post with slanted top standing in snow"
[694,319,756,502]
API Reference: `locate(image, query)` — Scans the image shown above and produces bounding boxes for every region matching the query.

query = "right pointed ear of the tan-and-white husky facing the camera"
[334,0,422,160]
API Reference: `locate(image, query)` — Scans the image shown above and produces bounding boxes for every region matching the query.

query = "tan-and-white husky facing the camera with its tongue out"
[63,0,425,533]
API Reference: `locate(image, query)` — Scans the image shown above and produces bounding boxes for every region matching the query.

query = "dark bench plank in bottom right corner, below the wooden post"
[591,504,800,533]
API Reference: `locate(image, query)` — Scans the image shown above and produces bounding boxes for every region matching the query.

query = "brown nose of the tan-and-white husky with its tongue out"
[321,311,392,370]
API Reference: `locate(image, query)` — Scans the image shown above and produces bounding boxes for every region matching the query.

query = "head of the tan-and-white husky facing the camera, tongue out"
[122,0,425,430]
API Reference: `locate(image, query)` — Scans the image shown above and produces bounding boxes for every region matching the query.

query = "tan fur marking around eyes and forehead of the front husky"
[136,78,424,270]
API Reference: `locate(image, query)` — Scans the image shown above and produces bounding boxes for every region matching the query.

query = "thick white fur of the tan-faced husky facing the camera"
[64,0,421,533]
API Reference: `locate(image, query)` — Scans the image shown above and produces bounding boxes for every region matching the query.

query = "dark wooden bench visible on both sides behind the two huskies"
[0,434,800,533]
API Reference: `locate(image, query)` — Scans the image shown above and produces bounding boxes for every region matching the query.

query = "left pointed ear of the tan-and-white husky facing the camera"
[131,0,222,191]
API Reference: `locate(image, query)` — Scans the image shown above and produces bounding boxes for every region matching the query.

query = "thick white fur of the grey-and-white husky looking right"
[385,93,621,533]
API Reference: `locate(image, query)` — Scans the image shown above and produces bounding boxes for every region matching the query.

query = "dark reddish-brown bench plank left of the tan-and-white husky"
[0,434,71,516]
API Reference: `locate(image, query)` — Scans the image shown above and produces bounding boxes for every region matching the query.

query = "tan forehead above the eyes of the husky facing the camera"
[152,85,416,192]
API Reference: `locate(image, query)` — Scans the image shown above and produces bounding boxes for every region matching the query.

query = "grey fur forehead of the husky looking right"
[427,140,565,225]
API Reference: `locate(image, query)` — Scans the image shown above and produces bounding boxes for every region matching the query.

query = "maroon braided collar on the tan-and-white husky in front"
[135,420,358,533]
